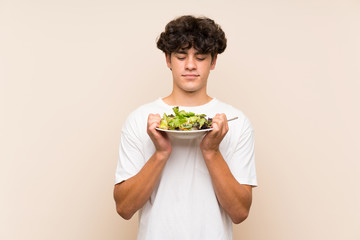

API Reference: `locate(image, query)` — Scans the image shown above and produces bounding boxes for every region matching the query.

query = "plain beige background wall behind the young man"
[0,0,360,240]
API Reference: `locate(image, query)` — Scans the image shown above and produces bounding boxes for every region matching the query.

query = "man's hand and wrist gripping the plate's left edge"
[147,114,171,159]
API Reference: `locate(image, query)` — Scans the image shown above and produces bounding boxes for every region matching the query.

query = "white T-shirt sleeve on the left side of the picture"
[115,115,145,184]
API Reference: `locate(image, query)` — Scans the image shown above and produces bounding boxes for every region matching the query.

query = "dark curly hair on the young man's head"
[157,15,226,57]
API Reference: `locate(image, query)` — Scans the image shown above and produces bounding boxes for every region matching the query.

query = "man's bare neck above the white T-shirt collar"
[163,91,212,107]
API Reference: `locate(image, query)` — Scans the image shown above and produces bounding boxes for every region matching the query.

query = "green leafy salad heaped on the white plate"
[160,107,212,131]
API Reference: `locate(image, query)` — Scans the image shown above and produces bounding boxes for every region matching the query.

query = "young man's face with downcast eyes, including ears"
[166,48,216,92]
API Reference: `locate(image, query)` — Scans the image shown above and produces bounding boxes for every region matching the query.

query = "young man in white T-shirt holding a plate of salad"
[114,16,257,240]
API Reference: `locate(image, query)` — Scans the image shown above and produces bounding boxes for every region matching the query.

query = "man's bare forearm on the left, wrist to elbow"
[114,153,169,219]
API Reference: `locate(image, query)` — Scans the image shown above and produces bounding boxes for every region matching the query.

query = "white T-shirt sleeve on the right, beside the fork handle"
[229,118,257,186]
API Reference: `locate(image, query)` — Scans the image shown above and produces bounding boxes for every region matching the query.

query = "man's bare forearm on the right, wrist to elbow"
[203,151,252,223]
